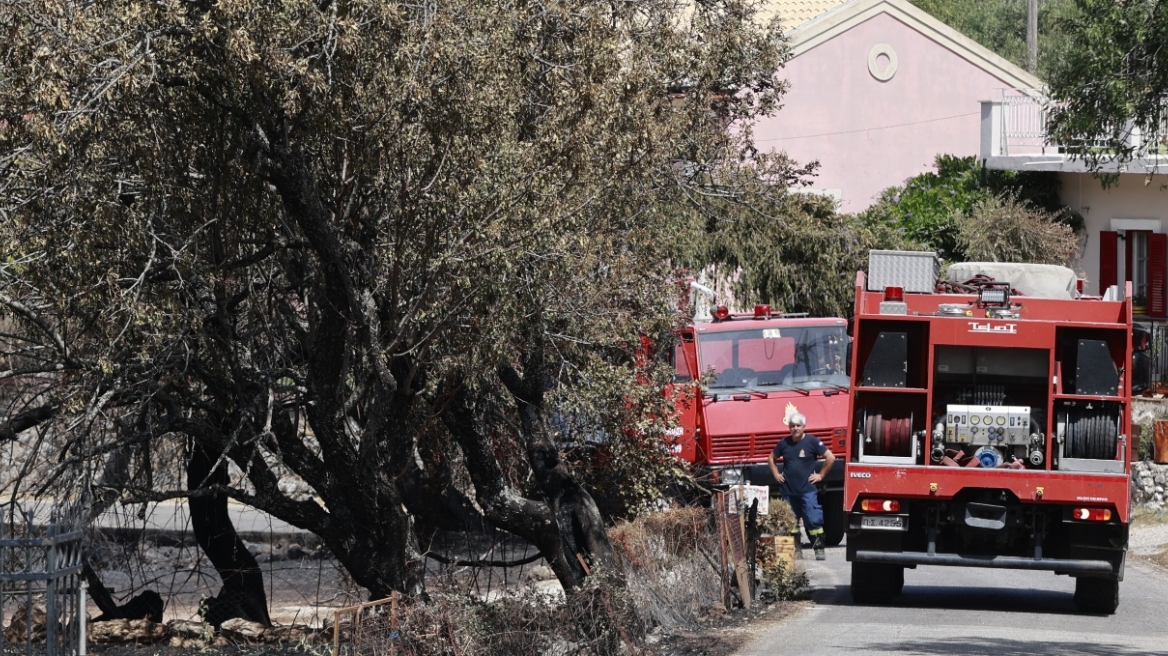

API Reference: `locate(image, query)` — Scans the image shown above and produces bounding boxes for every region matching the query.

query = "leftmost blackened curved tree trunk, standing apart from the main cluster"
[187,440,272,628]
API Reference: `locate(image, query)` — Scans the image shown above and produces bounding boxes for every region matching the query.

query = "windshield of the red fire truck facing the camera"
[697,326,848,391]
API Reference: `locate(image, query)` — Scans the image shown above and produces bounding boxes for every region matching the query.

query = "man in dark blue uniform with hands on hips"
[767,412,835,560]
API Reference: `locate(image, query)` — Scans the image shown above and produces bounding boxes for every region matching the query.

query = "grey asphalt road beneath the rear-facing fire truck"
[737,546,1168,656]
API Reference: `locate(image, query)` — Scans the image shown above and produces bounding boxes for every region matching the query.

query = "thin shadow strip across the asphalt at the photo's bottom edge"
[864,636,1168,656]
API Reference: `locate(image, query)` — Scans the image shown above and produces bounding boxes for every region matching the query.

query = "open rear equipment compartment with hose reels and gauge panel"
[851,327,1127,473]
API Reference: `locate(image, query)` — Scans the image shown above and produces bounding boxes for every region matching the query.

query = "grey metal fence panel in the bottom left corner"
[0,504,85,656]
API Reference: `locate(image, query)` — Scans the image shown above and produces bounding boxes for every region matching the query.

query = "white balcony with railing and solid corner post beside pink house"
[981,89,1168,174]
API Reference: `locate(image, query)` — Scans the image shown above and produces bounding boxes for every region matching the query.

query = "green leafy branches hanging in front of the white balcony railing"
[1047,0,1168,168]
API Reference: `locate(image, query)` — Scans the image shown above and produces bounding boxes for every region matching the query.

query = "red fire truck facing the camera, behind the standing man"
[666,305,849,546]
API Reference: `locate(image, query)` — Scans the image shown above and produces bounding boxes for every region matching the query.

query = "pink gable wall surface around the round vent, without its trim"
[755,14,1023,212]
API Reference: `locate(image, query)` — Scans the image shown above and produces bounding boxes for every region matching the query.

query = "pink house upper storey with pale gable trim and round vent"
[755,0,1041,212]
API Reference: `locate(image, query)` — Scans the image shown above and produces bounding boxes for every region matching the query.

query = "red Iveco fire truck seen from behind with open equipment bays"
[844,253,1135,613]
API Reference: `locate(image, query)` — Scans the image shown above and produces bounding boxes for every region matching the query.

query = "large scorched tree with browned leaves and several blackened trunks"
[0,0,785,596]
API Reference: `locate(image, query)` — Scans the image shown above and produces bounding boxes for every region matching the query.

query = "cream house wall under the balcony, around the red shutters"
[1059,173,1168,294]
